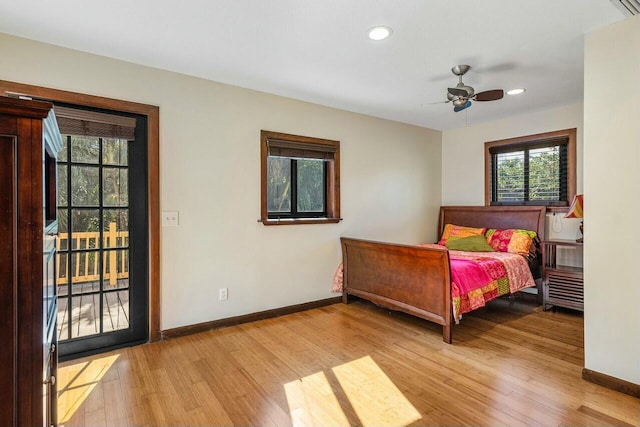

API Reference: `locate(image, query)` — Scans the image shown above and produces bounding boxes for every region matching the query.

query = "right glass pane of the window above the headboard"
[529,146,560,201]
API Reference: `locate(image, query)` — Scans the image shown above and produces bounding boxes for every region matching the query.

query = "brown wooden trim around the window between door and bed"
[258,130,342,225]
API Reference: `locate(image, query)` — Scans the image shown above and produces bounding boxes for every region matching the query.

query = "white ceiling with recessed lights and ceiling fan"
[0,0,624,130]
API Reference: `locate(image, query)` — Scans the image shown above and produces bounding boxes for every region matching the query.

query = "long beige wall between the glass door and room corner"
[0,35,442,329]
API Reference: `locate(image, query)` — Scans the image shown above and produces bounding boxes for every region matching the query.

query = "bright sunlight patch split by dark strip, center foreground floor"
[284,356,422,427]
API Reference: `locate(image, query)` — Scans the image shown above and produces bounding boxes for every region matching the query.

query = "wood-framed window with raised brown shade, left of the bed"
[260,130,340,225]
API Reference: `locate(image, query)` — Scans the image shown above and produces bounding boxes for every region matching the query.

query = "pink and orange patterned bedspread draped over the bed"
[331,249,535,323]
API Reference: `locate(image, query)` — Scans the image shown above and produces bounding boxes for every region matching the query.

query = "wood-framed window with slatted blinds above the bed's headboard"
[485,129,576,206]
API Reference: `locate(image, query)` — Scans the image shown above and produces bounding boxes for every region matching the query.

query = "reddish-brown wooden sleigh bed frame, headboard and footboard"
[340,206,546,343]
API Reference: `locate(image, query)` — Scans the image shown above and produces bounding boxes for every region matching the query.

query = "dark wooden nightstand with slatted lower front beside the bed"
[542,240,584,311]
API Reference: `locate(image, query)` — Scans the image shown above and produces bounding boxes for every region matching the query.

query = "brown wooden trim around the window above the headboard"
[484,128,577,210]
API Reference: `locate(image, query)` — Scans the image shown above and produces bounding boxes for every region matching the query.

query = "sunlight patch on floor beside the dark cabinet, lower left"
[58,354,119,424]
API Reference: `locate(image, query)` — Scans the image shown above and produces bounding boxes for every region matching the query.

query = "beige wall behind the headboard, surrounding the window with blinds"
[442,103,583,242]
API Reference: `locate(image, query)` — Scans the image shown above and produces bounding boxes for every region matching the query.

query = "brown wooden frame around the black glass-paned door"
[0,80,162,342]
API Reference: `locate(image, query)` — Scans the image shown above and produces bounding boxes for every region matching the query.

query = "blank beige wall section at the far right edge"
[584,16,640,384]
